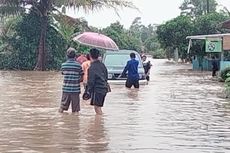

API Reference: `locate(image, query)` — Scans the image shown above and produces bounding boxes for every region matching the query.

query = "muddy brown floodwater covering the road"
[0,60,230,153]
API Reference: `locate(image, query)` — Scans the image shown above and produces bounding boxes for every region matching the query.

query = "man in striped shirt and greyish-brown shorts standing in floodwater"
[59,48,83,114]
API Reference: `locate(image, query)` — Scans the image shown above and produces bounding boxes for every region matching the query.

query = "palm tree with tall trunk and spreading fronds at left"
[0,0,135,70]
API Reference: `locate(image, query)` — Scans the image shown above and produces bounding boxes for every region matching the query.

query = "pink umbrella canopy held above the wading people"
[73,32,119,50]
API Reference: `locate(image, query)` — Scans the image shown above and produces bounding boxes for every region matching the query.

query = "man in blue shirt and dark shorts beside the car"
[121,53,139,88]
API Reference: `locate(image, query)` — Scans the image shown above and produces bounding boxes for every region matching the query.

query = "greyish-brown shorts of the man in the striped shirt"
[61,92,80,112]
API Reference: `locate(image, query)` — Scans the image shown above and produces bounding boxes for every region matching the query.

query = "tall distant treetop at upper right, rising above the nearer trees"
[180,0,218,17]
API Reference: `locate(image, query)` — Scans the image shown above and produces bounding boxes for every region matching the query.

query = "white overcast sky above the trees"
[64,0,230,28]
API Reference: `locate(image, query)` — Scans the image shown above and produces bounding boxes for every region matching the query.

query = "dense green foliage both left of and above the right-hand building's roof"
[157,12,227,58]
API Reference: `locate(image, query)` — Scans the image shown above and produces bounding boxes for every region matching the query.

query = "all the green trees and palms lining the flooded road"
[0,0,230,70]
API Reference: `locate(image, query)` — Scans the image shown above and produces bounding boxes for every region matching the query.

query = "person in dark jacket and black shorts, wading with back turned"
[87,48,109,115]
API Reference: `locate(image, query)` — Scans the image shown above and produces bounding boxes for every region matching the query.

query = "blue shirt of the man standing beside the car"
[122,58,139,80]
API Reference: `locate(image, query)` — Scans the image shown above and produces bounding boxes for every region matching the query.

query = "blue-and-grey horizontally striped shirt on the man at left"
[61,59,83,93]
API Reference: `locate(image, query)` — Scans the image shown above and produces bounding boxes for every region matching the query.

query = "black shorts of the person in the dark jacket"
[90,92,106,107]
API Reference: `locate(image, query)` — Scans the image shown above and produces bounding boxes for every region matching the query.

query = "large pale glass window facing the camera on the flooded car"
[104,54,142,67]
